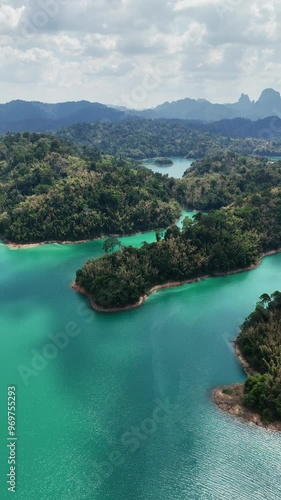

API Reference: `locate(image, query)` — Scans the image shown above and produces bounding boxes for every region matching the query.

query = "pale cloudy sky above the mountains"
[0,0,281,109]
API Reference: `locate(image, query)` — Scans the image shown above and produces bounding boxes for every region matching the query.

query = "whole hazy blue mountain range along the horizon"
[0,89,281,133]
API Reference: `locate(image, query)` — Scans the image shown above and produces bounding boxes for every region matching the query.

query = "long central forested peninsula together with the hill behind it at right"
[74,150,281,312]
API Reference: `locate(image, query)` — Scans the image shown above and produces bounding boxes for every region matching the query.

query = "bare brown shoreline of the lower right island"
[212,346,281,432]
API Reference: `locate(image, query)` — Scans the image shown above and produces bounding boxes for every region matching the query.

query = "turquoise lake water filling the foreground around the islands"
[0,213,281,500]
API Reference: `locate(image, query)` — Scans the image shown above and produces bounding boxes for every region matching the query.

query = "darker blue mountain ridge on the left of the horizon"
[0,100,125,133]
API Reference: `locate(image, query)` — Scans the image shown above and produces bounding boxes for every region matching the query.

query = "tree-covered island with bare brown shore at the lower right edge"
[213,291,281,431]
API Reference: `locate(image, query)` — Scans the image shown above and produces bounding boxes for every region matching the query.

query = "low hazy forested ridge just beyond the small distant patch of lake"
[56,118,281,159]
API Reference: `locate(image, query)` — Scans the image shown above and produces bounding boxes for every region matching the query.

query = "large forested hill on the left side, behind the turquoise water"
[0,133,180,243]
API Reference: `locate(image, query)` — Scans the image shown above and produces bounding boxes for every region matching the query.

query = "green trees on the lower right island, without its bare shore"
[237,291,281,422]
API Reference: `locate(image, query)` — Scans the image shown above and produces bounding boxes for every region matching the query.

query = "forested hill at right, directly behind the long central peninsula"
[173,152,281,210]
